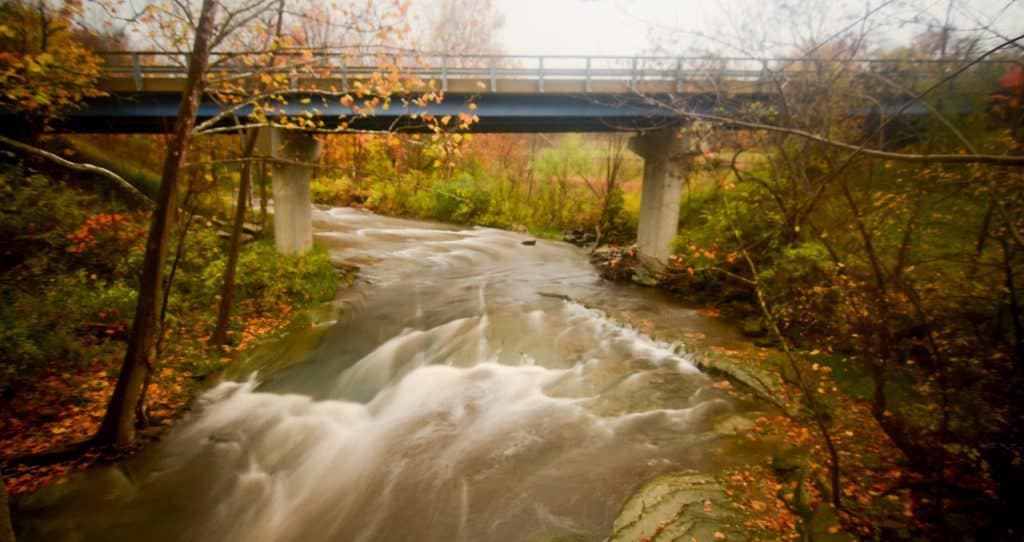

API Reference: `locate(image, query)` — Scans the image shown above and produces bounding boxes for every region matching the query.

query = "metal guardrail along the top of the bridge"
[98,49,1013,92]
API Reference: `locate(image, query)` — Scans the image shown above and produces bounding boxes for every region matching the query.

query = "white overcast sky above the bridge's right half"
[493,0,1024,54]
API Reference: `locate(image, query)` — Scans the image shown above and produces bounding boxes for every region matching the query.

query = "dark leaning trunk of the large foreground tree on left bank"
[96,0,217,446]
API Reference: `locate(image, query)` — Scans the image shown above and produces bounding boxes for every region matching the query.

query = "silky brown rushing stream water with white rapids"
[18,205,765,542]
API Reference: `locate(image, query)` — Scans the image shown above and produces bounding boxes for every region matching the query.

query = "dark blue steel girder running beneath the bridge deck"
[28,92,768,133]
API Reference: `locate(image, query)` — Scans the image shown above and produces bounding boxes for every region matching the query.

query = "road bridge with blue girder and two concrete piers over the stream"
[25,50,1007,266]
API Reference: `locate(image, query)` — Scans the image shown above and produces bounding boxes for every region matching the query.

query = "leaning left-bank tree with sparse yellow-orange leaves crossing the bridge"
[98,0,475,445]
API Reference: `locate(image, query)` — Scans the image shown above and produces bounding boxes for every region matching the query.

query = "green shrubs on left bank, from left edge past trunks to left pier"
[0,159,338,394]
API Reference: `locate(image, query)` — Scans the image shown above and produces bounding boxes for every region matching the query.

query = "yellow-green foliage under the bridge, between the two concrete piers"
[311,134,640,236]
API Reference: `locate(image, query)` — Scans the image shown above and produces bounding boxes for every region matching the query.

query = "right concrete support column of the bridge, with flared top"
[630,128,700,270]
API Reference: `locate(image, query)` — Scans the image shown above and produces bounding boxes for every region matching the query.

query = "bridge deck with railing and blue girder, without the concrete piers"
[8,51,998,133]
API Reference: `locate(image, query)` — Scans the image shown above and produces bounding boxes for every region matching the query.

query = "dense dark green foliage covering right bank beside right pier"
[655,49,1024,539]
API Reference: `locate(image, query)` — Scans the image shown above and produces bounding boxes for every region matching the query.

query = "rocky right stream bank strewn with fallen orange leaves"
[581,242,914,542]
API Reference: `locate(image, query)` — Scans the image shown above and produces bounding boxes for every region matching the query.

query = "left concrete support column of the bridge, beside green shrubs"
[259,127,321,254]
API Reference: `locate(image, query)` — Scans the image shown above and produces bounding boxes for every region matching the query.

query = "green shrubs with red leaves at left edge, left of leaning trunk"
[0,164,138,391]
